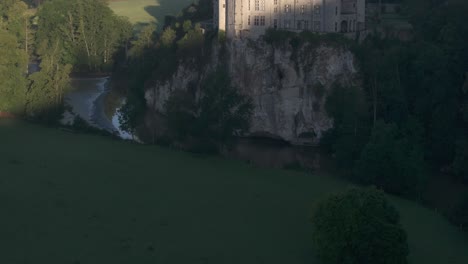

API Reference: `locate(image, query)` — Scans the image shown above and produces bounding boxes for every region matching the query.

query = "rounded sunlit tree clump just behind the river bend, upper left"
[37,0,132,71]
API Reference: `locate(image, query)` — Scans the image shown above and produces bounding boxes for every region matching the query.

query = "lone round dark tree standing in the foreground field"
[312,189,409,264]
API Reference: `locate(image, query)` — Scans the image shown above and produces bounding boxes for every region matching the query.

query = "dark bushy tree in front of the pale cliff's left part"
[165,70,253,151]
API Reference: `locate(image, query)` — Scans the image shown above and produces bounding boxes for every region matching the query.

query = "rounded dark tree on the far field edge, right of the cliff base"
[353,119,426,195]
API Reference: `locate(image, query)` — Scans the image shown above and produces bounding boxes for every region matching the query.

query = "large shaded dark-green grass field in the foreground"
[0,120,468,264]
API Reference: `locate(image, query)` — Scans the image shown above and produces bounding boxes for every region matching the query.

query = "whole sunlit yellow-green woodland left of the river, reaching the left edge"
[0,0,132,122]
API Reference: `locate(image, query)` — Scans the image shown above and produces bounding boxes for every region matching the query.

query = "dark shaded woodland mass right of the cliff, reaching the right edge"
[323,1,468,195]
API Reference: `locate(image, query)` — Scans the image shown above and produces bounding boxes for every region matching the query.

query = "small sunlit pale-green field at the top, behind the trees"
[109,0,193,26]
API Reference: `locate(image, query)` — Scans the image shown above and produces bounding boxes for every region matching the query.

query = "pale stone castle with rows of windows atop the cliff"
[213,0,366,38]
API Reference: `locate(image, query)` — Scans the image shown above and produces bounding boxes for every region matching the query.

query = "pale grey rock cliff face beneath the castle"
[146,39,358,144]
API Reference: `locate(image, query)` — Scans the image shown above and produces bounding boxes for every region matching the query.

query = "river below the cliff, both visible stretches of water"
[62,77,323,170]
